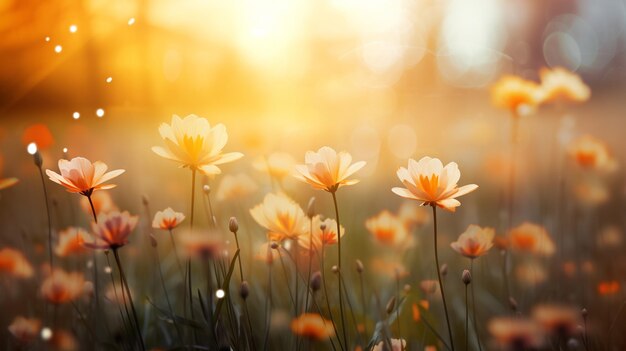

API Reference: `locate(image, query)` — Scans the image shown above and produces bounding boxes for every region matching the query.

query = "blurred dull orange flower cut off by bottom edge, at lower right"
[487,317,545,350]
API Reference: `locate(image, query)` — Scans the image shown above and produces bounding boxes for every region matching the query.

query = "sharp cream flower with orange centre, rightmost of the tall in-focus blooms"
[391,156,478,212]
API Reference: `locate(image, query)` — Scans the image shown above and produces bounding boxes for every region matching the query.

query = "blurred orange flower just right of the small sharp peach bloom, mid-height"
[509,222,556,256]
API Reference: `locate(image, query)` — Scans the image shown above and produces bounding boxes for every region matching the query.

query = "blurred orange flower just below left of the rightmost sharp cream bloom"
[365,210,411,248]
